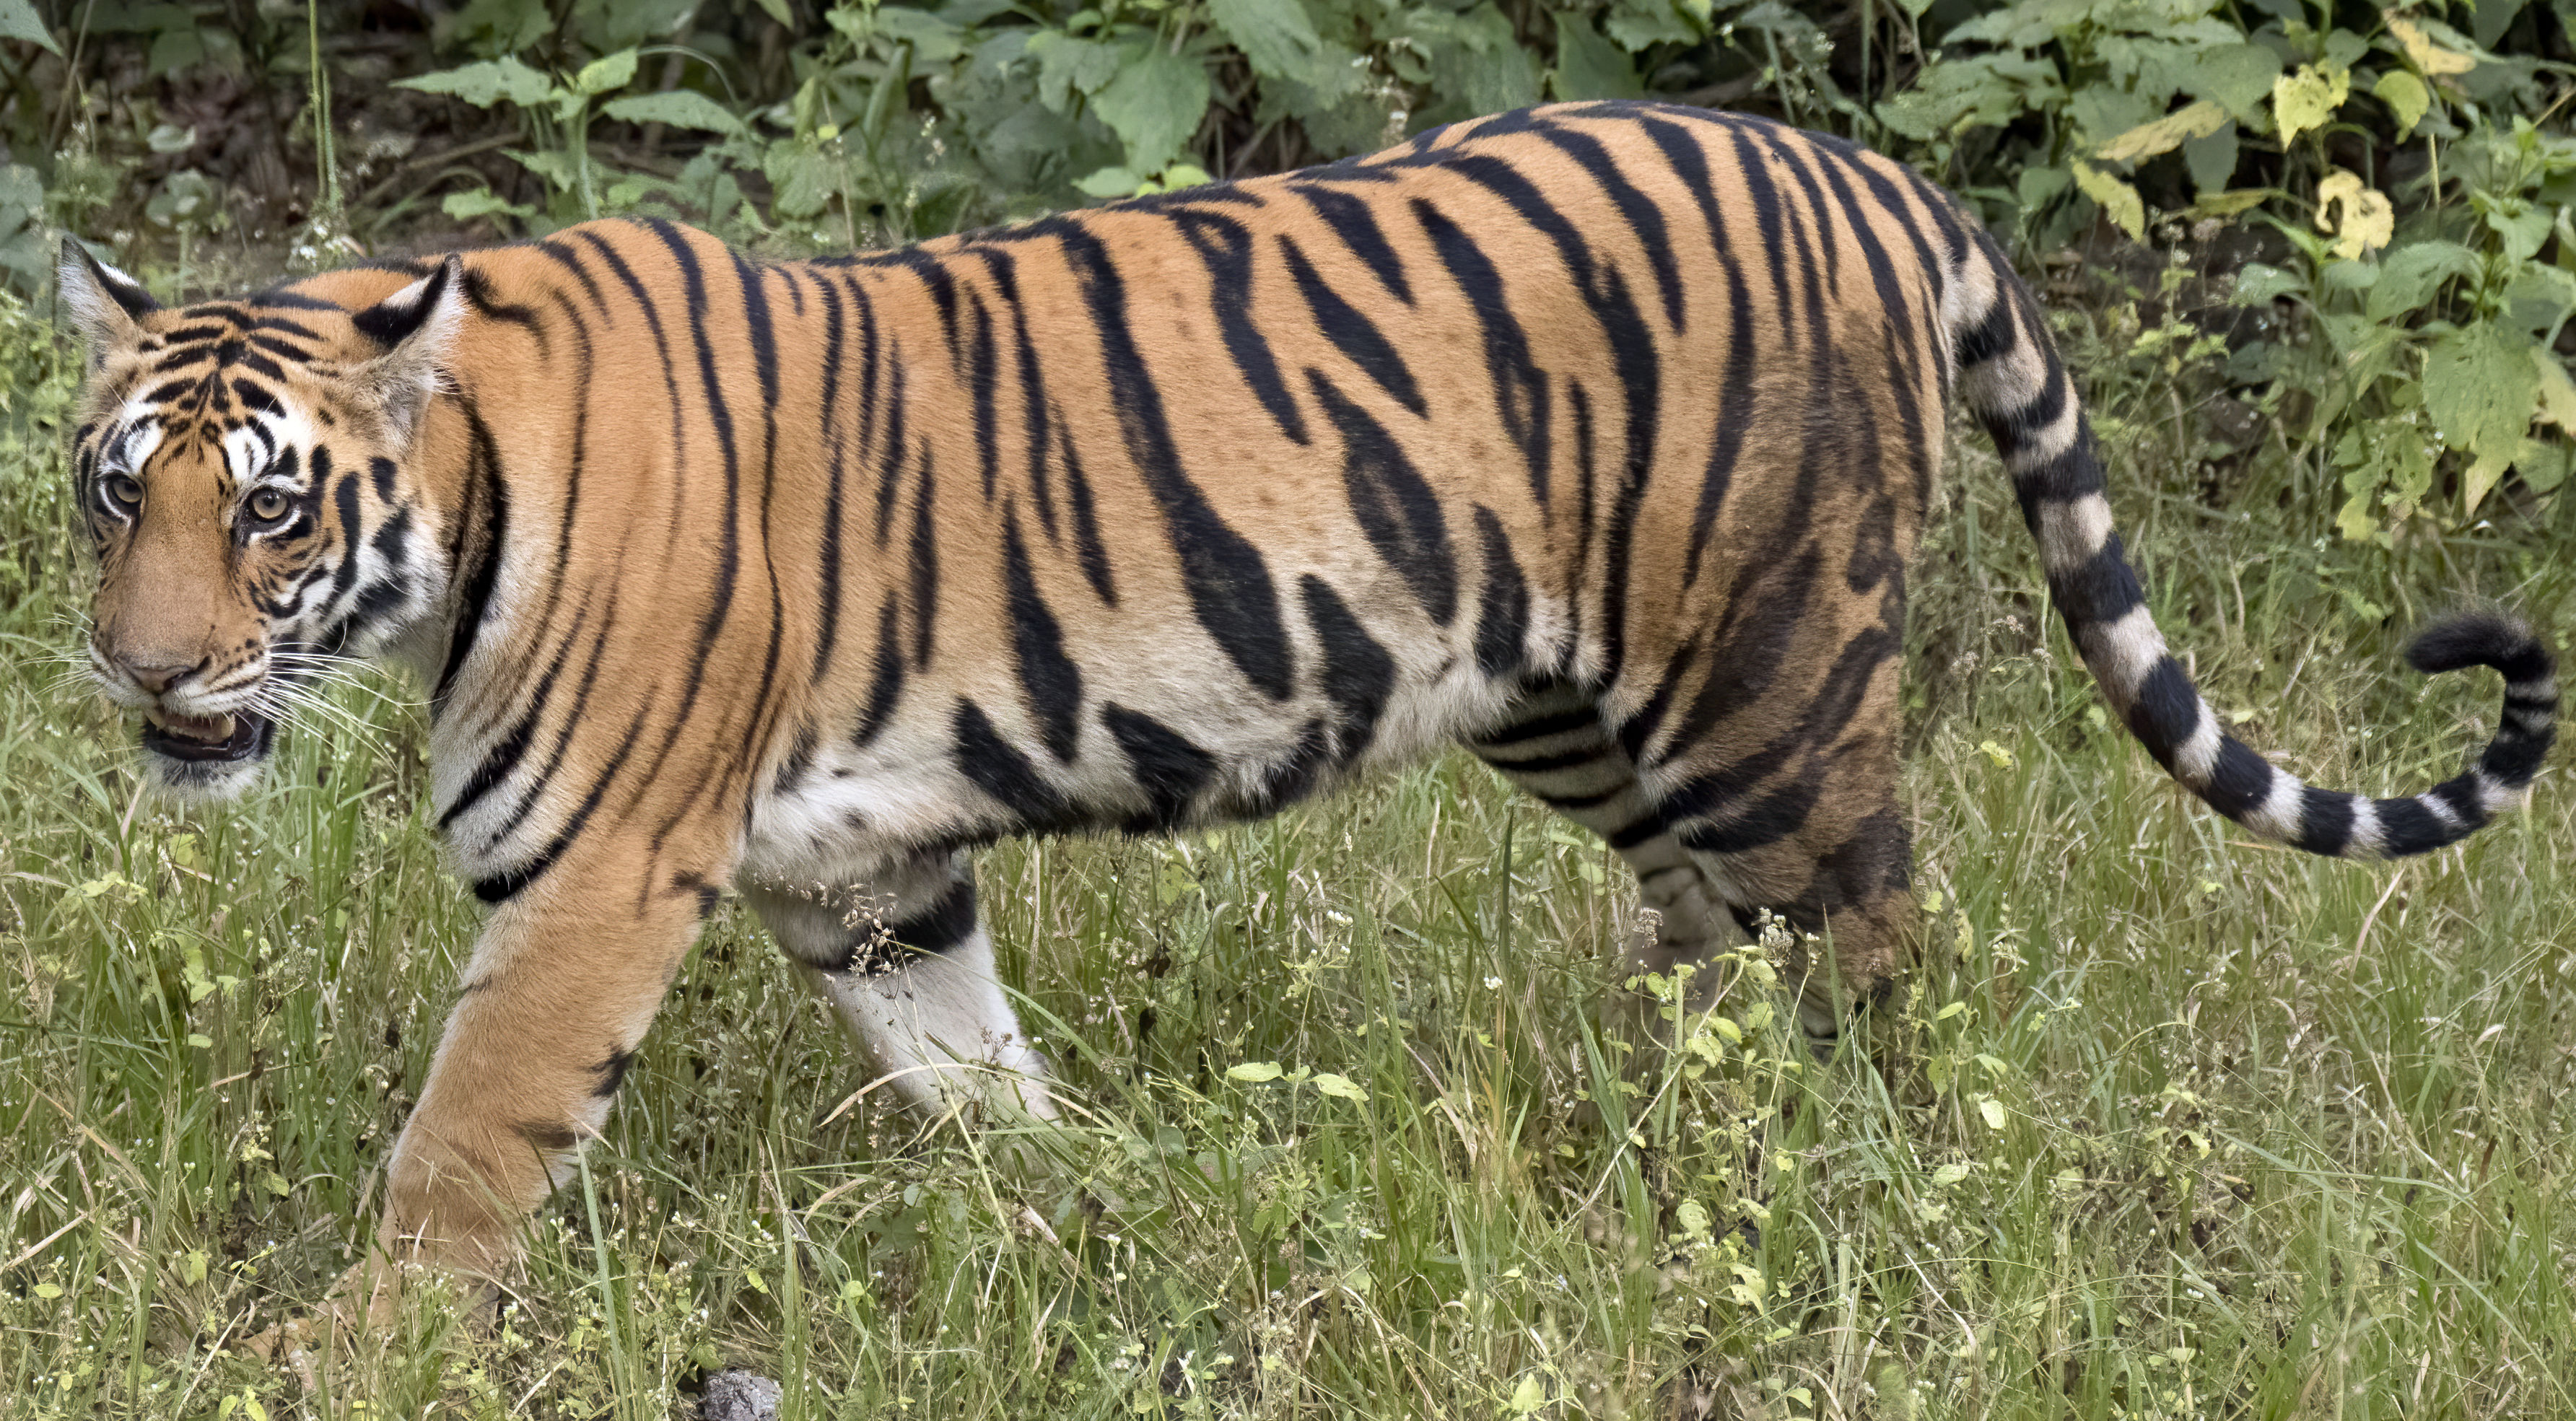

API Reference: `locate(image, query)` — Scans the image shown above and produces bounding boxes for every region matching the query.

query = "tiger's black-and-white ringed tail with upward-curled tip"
[1942,235,2558,857]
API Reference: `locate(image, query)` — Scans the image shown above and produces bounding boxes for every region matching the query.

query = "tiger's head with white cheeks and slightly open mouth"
[62,242,466,798]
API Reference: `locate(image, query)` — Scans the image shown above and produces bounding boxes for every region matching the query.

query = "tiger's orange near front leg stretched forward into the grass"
[340,834,724,1323]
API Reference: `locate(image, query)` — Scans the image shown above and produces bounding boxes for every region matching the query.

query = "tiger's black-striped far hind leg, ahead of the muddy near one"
[1468,682,1747,1009]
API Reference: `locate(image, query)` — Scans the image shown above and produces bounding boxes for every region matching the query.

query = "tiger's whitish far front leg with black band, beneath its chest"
[744,849,1056,1120]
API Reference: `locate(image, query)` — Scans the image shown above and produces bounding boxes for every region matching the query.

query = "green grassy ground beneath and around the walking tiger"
[0,280,2576,1421]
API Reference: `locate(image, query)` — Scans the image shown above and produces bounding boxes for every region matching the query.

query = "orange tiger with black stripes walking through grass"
[59,103,2558,1318]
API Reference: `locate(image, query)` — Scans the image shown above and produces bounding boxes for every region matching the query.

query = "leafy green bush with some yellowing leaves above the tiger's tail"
[1878,0,2576,541]
